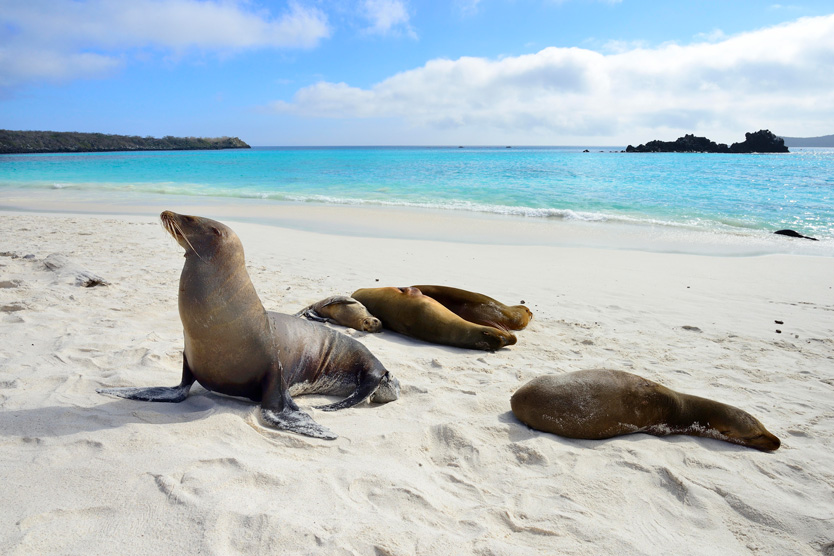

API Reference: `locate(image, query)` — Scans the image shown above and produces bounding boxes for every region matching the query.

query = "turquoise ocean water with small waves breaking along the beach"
[0,147,834,242]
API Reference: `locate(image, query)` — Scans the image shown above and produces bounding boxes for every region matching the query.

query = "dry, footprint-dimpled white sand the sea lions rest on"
[0,210,834,555]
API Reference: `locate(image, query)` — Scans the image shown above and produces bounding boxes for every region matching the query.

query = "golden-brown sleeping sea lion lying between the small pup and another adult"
[351,288,516,351]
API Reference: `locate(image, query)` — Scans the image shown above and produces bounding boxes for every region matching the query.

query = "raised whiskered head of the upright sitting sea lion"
[159,210,243,261]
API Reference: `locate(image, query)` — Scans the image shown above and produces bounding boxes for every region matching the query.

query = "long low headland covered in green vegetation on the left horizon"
[0,129,250,154]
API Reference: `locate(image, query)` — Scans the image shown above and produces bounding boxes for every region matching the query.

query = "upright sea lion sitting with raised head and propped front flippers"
[98,211,399,440]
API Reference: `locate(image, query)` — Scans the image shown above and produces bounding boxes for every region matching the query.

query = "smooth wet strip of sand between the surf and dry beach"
[0,188,834,257]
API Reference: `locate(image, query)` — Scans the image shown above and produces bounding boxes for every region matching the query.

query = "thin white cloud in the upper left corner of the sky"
[0,0,330,87]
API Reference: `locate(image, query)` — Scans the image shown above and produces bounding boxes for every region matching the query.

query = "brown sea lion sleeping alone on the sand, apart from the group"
[510,370,780,451]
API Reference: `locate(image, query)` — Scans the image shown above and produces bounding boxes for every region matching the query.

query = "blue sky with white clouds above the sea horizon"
[0,0,834,146]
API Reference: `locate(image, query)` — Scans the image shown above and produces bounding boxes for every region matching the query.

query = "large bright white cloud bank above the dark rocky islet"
[273,16,834,144]
